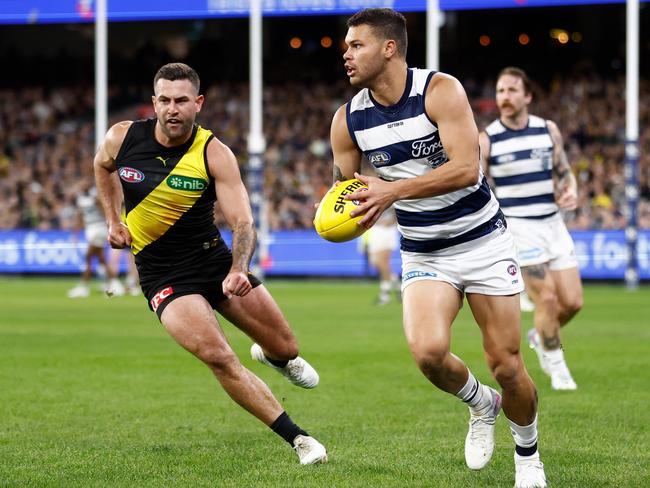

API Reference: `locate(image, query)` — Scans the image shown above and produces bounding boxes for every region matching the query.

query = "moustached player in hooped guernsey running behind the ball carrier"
[480,67,582,390]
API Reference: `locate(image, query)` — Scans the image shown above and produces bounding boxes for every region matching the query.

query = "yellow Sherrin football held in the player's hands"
[314,179,368,242]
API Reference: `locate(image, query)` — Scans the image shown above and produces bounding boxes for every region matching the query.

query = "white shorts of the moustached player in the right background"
[507,213,578,270]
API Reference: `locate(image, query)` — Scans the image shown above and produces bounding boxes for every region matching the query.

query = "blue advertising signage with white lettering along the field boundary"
[0,230,650,280]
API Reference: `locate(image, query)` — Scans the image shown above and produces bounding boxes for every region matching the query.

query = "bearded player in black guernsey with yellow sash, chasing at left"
[94,63,327,464]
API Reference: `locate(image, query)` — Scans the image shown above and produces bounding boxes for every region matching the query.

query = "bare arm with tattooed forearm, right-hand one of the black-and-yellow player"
[207,139,257,298]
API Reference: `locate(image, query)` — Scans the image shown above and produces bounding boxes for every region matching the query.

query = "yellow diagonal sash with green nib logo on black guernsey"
[126,127,212,254]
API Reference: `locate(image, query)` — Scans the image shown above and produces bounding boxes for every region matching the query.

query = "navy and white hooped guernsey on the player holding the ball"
[346,68,506,253]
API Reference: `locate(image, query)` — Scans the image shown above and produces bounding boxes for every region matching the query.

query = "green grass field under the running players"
[0,277,650,488]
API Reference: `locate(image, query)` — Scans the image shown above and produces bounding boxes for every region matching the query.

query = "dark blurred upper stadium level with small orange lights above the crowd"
[0,0,650,87]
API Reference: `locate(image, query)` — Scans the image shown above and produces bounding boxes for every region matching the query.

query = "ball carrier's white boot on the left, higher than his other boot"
[465,385,501,470]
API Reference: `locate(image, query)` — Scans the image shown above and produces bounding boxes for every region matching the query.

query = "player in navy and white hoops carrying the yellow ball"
[331,9,546,487]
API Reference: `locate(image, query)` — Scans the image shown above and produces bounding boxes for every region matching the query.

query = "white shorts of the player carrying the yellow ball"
[402,229,524,295]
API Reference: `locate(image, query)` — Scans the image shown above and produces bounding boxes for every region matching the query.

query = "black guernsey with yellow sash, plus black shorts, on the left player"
[115,118,232,309]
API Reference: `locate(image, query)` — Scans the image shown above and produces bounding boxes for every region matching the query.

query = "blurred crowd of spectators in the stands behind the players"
[0,76,650,230]
